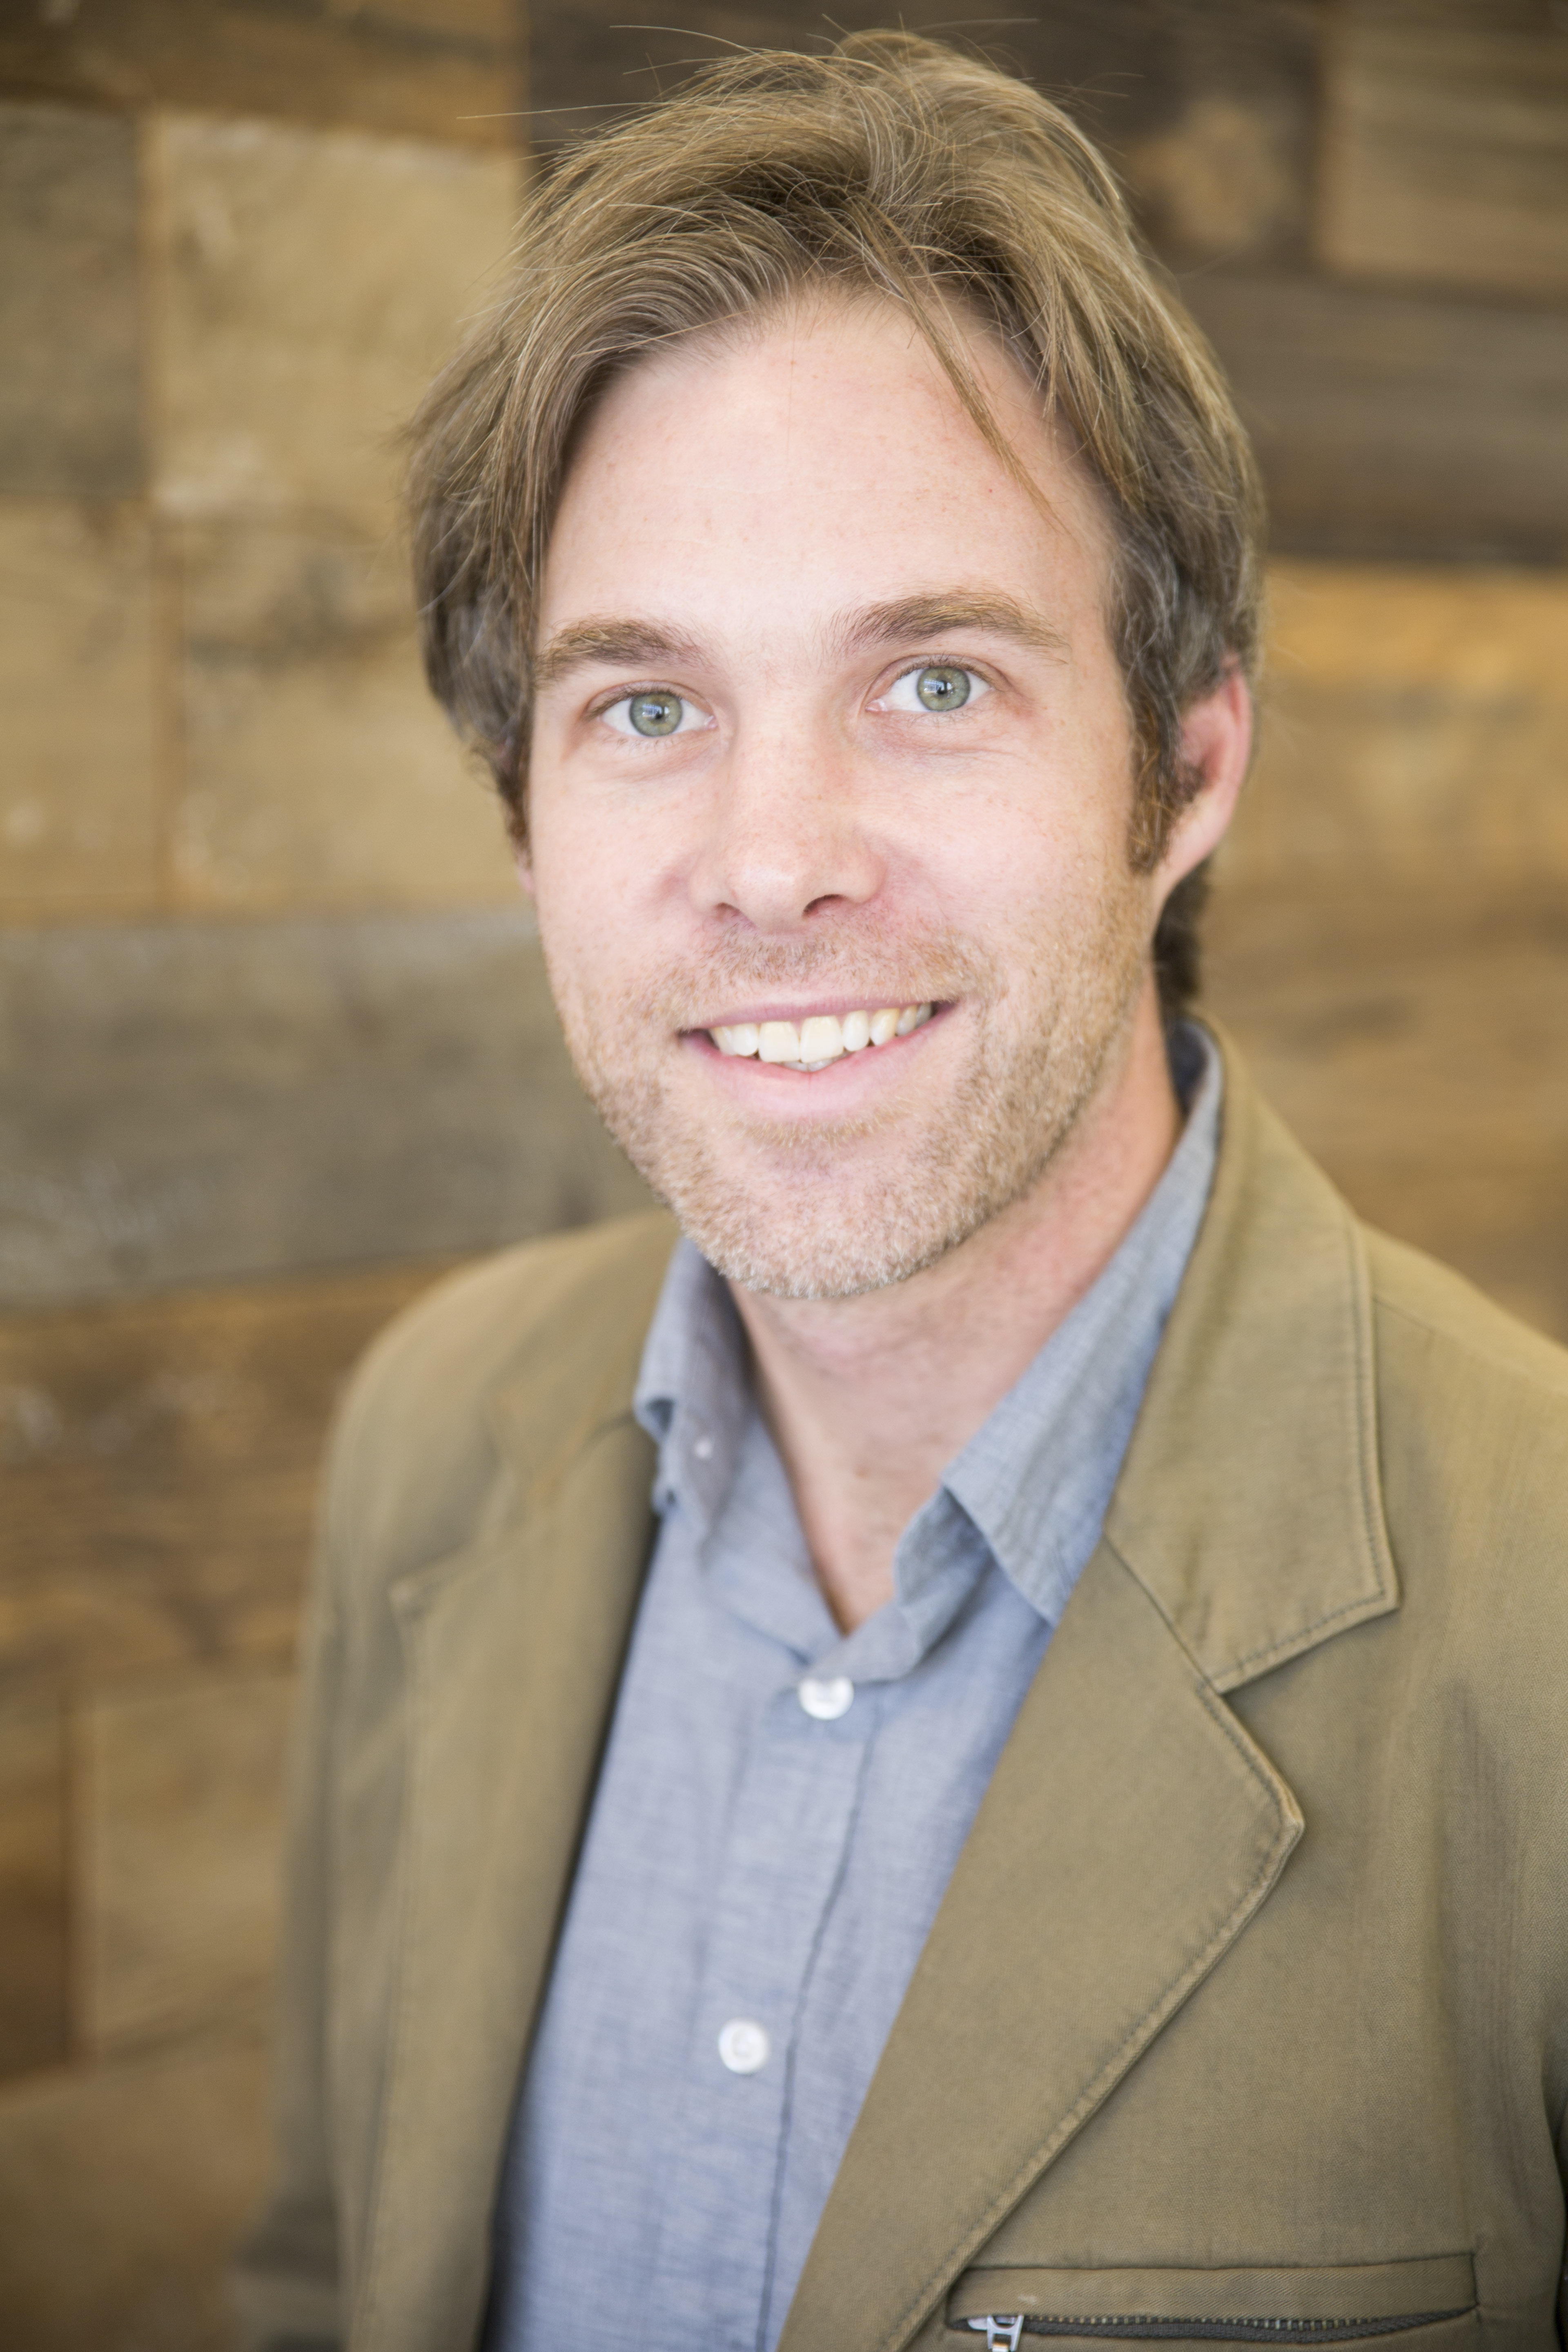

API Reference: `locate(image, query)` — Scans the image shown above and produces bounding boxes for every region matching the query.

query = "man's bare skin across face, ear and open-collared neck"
[524,301,1248,1623]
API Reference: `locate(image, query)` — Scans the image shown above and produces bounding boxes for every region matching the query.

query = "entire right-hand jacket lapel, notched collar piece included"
[778,1054,1399,2352]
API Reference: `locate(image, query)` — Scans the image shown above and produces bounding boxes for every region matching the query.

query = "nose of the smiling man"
[691,724,886,936]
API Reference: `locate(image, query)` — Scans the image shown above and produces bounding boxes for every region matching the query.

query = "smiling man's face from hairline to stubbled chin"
[527,301,1189,1298]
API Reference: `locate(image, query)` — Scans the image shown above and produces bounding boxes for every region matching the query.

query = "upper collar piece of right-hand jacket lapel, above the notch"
[1105,1011,1399,1691]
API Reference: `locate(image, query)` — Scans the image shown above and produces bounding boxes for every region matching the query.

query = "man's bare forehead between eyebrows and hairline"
[541,299,1109,630]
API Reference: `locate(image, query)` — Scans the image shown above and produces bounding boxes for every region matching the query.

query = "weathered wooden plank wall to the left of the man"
[0,0,541,2352]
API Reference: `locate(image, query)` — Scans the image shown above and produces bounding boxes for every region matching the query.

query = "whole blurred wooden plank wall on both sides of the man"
[0,0,1568,2352]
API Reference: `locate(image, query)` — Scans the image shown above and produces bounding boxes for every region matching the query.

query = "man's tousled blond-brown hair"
[411,33,1263,997]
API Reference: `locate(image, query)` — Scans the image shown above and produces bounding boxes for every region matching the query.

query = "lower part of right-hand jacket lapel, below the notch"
[780,1545,1302,2352]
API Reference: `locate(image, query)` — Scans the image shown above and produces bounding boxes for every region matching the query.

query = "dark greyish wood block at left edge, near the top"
[0,108,143,499]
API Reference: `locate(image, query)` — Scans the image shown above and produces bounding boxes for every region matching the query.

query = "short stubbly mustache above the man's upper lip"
[637,927,999,1030]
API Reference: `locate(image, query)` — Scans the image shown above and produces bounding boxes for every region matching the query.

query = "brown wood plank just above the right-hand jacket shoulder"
[1206,875,1568,1341]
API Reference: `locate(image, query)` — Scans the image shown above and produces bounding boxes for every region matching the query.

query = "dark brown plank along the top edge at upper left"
[0,0,522,146]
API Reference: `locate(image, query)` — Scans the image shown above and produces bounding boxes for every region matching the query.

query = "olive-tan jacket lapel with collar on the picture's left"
[353,1223,670,2352]
